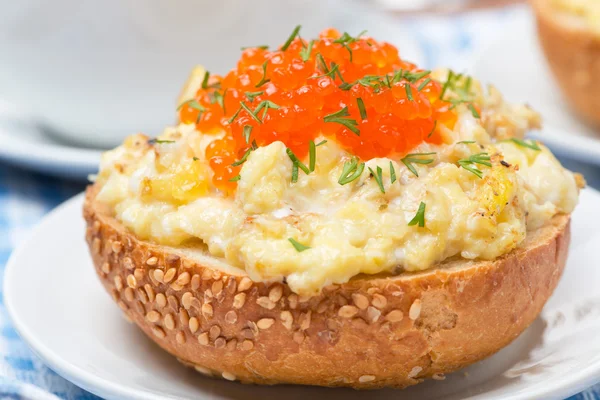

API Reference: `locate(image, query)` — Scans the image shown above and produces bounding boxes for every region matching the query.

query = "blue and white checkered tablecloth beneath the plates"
[0,3,600,400]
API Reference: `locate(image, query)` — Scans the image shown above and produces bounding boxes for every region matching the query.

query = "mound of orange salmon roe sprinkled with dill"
[179,28,456,192]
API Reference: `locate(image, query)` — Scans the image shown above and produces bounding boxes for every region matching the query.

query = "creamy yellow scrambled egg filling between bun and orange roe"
[97,85,578,294]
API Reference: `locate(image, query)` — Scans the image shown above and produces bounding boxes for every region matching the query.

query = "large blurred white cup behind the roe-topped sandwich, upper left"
[0,0,348,147]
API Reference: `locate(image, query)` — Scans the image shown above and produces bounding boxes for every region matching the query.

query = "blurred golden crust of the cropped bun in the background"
[531,0,600,126]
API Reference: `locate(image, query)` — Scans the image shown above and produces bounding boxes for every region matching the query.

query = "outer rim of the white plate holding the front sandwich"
[2,191,600,400]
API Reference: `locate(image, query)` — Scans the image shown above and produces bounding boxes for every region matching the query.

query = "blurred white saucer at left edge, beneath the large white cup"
[0,101,102,180]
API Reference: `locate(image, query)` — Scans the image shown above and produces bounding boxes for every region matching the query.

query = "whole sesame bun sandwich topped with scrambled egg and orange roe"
[84,27,583,388]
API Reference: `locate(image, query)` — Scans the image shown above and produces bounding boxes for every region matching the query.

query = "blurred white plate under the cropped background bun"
[471,15,600,165]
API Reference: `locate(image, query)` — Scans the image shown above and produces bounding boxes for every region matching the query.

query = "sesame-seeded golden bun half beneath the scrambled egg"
[84,186,569,389]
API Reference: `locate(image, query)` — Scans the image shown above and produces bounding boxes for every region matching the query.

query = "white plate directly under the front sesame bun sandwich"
[4,189,600,400]
